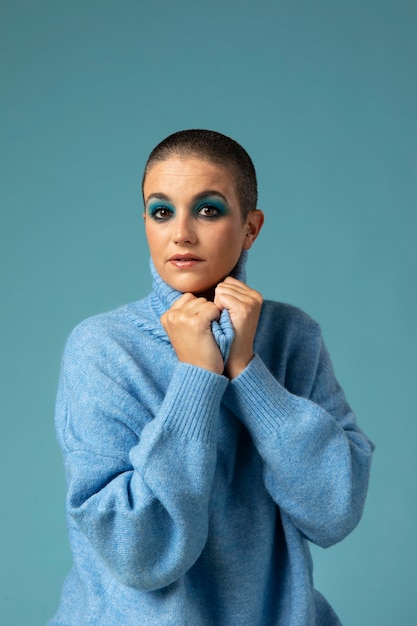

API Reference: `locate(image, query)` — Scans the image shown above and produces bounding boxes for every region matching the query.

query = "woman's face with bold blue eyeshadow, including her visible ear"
[143,157,261,294]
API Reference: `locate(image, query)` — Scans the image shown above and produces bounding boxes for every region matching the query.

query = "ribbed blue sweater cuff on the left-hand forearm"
[161,362,228,443]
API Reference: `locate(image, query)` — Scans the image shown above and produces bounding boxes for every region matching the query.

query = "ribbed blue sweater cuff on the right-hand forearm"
[225,355,300,438]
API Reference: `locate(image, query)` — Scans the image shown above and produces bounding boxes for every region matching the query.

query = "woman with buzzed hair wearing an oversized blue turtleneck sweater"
[50,130,372,626]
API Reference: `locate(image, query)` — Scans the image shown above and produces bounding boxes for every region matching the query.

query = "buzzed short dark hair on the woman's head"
[142,129,258,220]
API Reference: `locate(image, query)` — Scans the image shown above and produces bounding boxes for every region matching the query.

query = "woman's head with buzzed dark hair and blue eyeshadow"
[142,131,263,294]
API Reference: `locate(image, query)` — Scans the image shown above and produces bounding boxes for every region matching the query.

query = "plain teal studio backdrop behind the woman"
[0,0,417,626]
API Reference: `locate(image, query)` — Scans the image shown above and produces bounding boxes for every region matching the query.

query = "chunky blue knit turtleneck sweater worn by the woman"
[49,259,372,626]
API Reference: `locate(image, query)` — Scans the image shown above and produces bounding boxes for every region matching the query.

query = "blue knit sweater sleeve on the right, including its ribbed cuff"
[226,336,373,547]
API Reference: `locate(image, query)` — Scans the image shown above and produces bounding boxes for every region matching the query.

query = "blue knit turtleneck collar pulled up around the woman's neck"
[150,250,248,363]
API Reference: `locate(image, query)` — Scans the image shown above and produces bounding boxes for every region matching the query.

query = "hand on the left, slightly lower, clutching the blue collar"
[161,293,224,374]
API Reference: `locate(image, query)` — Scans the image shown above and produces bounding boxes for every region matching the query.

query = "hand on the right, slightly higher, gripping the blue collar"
[214,276,263,378]
